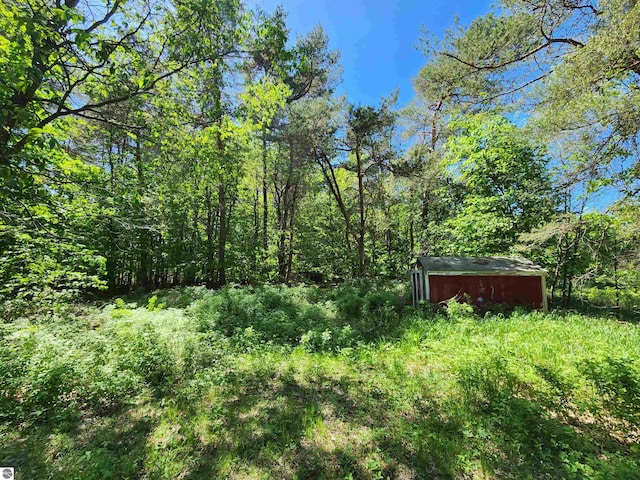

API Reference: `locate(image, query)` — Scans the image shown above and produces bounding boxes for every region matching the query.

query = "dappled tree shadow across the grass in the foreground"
[5,359,640,480]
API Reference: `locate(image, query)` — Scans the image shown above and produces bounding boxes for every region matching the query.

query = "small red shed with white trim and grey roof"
[409,257,547,311]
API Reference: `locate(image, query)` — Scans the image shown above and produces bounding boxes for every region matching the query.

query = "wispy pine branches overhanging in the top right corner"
[416,0,640,194]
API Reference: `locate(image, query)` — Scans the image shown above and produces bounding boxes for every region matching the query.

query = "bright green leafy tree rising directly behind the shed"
[429,112,556,255]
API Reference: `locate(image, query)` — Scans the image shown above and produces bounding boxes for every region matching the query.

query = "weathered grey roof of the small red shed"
[418,257,546,275]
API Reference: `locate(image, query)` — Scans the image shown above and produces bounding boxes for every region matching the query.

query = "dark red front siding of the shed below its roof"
[429,275,543,308]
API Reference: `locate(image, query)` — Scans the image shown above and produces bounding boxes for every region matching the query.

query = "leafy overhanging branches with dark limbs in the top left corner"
[0,0,238,176]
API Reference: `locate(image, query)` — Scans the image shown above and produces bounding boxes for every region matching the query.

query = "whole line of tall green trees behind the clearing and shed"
[0,0,640,314]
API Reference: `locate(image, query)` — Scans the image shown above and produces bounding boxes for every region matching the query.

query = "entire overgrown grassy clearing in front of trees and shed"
[0,286,640,479]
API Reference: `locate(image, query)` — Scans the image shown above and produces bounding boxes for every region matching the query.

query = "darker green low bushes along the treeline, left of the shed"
[189,283,407,350]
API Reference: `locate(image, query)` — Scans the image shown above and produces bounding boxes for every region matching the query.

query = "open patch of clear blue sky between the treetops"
[249,0,491,106]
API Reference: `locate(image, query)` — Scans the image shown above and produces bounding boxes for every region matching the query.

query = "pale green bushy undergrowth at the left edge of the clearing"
[0,301,216,423]
